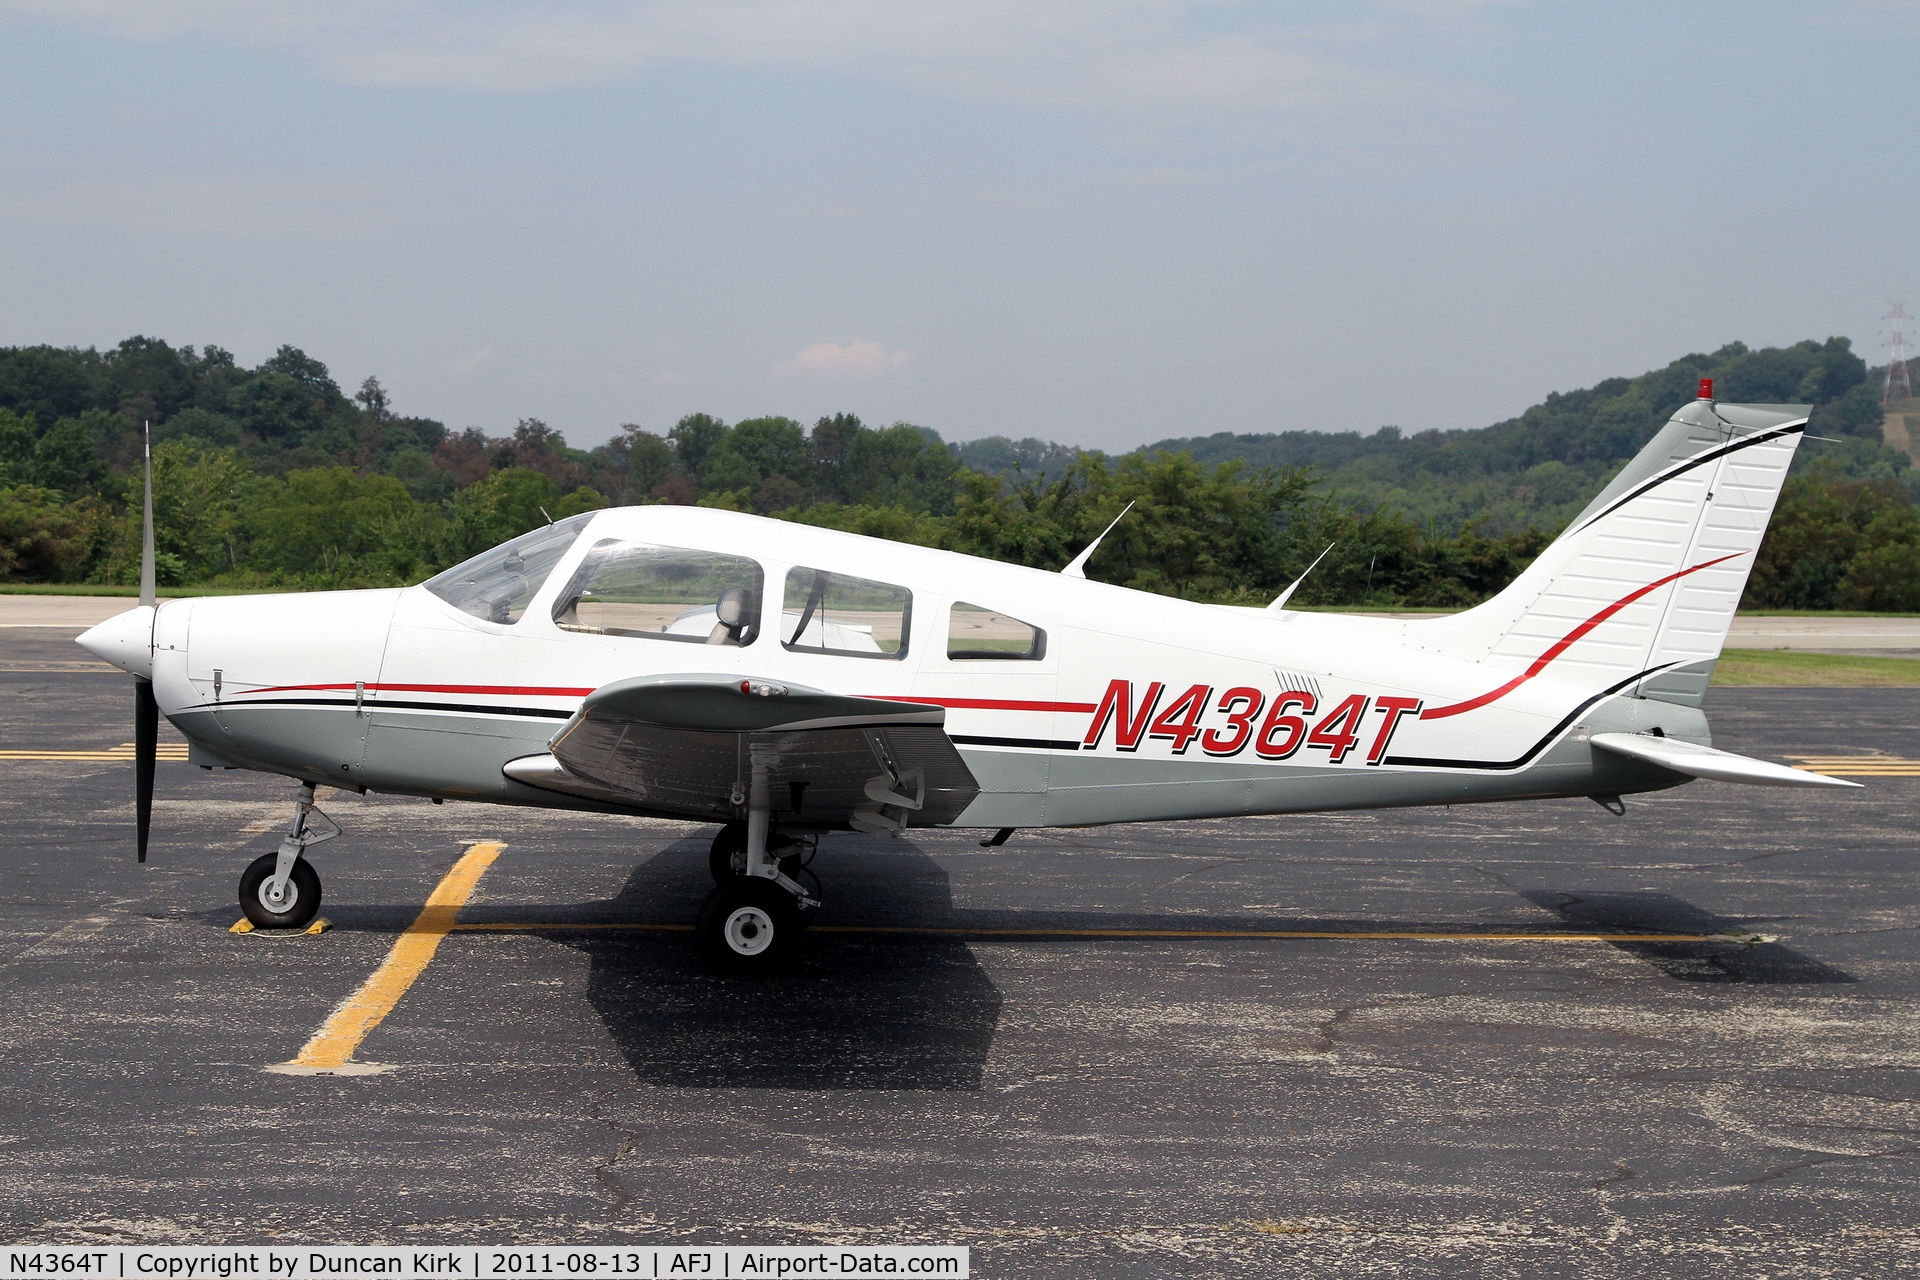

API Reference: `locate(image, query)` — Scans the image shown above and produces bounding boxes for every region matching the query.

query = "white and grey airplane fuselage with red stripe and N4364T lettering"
[94,507,1707,827]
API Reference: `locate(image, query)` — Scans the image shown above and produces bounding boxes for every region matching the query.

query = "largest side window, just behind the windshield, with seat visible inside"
[553,539,764,645]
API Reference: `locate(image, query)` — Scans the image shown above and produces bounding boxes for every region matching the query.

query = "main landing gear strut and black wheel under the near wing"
[693,743,820,977]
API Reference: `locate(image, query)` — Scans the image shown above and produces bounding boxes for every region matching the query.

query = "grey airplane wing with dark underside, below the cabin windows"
[505,676,979,831]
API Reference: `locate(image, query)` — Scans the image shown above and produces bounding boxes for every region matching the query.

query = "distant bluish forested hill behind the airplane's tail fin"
[1121,338,1907,533]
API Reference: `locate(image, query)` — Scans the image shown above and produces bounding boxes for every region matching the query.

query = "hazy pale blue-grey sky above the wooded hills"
[0,0,1920,449]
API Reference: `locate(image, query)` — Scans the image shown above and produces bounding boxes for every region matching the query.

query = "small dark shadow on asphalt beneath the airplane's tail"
[1521,889,1859,984]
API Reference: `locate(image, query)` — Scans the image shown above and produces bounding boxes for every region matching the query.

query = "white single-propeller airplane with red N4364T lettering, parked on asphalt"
[79,382,1855,973]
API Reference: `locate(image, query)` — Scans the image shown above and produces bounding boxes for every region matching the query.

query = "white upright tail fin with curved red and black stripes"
[1421,397,1807,706]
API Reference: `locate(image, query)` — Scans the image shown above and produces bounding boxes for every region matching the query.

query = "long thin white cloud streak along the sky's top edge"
[0,0,1482,113]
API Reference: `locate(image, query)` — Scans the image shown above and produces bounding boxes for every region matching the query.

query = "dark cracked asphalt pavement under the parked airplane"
[0,631,1920,1276]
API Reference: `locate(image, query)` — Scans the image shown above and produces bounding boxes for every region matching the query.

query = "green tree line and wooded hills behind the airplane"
[0,338,1920,608]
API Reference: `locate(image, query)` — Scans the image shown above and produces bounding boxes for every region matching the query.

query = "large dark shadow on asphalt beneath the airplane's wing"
[549,839,1000,1090]
